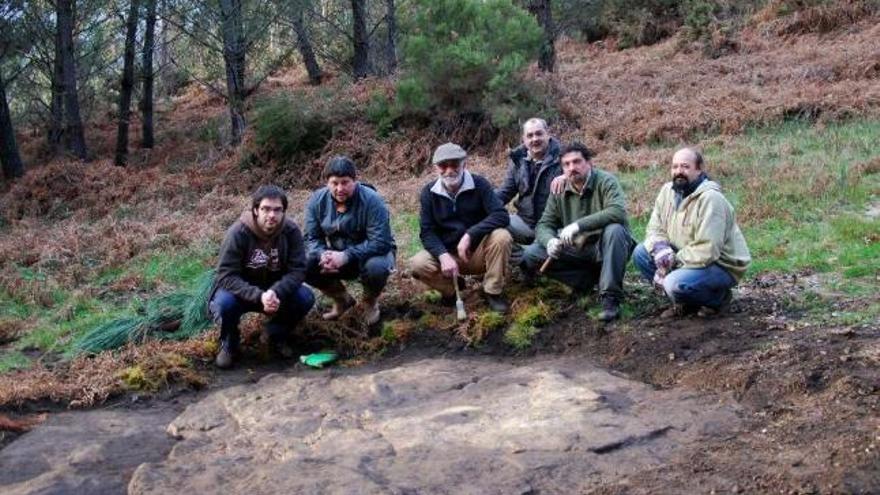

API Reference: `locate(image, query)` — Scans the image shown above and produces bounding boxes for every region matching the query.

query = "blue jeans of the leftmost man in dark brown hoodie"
[210,285,315,352]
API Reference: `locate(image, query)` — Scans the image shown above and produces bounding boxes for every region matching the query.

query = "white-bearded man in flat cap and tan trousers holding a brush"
[410,143,513,313]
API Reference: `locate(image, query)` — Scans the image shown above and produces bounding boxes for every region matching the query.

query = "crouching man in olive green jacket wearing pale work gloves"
[522,142,635,322]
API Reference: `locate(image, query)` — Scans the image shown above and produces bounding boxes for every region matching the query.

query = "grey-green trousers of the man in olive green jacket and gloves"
[523,223,634,300]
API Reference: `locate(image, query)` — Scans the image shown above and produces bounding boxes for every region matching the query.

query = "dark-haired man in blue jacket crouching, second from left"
[305,156,397,325]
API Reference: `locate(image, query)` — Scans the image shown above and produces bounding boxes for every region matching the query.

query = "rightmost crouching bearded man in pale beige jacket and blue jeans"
[634,148,752,317]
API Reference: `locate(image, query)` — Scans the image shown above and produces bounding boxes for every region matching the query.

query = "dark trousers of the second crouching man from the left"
[306,251,394,297]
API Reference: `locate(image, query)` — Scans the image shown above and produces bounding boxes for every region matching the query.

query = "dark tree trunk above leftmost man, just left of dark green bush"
[220,0,246,145]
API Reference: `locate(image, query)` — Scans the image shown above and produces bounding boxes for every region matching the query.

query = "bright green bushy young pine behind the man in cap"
[396,0,542,127]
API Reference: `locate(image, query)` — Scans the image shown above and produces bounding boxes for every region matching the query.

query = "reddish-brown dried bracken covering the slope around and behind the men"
[0,9,880,406]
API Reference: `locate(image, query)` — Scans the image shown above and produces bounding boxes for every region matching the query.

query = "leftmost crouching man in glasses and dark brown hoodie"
[209,185,315,368]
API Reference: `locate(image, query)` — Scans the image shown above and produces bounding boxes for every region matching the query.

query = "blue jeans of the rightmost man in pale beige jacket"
[633,244,736,308]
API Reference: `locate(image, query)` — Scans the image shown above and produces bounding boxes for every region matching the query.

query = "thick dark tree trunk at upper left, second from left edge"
[56,0,88,160]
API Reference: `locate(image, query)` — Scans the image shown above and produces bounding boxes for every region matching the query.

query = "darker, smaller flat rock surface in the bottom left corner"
[0,407,180,495]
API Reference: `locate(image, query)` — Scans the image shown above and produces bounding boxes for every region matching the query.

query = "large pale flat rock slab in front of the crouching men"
[129,358,739,495]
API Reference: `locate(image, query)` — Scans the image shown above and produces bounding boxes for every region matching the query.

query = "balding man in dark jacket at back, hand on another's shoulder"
[495,118,562,245]
